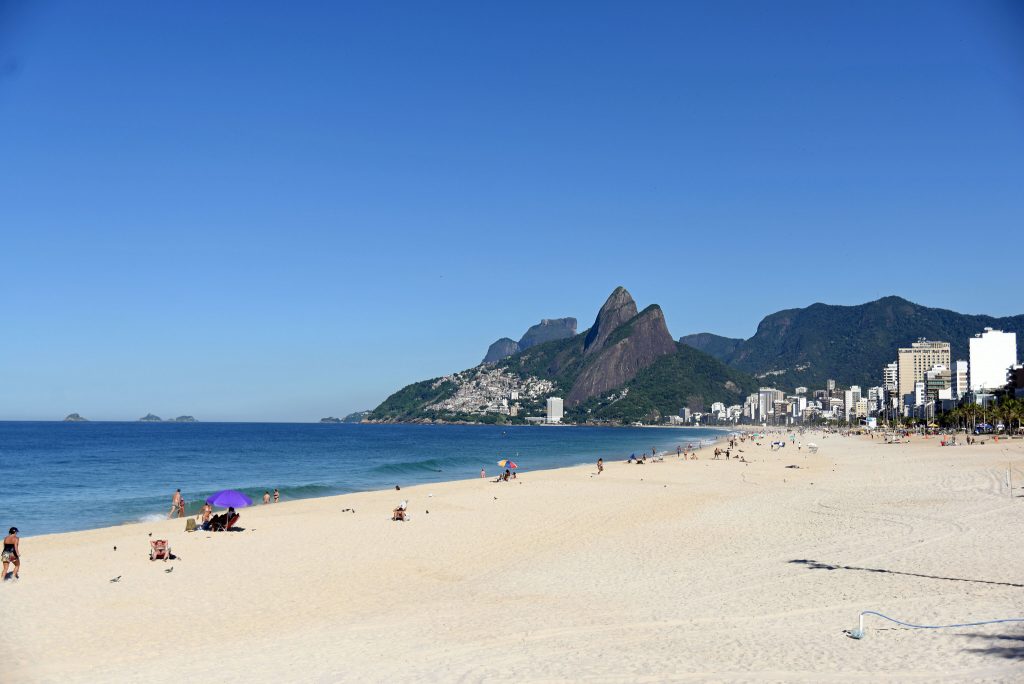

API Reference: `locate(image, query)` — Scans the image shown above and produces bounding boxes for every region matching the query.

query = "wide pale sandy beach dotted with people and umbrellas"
[0,434,1024,682]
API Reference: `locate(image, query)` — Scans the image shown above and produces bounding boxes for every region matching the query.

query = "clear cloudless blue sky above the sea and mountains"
[0,0,1024,421]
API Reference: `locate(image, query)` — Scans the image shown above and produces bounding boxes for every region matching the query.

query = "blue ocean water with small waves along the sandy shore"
[0,422,724,537]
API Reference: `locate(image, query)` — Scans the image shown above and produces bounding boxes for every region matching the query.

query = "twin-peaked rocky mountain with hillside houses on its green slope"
[369,288,756,422]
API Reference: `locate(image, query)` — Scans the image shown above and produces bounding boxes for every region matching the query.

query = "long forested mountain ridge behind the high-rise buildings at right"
[682,296,1024,389]
